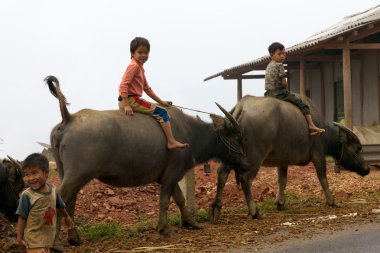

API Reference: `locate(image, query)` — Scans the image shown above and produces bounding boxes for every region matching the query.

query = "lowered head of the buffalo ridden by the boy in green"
[334,122,370,176]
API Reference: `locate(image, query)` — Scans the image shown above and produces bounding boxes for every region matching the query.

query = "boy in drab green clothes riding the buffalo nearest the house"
[264,42,325,135]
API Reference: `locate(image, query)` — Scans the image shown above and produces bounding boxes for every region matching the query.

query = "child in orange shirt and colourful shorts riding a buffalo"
[118,37,189,149]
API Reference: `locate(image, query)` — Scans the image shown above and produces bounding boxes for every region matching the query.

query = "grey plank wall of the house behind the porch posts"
[290,50,380,126]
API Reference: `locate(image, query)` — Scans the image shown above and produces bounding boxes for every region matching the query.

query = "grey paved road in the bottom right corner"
[262,222,380,253]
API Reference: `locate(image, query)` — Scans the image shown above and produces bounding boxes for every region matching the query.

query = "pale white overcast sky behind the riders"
[0,0,379,160]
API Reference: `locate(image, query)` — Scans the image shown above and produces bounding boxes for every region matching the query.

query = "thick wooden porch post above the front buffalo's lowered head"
[343,42,353,129]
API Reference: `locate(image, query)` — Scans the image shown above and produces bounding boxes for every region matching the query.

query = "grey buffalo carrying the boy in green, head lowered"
[209,96,370,221]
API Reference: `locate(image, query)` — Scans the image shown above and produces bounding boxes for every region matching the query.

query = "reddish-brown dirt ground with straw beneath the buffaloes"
[0,163,380,253]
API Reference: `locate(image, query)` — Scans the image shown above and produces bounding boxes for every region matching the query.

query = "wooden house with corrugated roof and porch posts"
[205,5,380,132]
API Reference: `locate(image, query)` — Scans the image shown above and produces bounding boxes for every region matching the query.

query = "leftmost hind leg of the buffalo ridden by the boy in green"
[208,165,231,222]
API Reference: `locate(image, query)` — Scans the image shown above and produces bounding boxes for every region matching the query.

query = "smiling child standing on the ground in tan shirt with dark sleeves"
[16,153,74,253]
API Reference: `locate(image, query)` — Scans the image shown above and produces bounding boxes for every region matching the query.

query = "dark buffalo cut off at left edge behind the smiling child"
[0,158,24,222]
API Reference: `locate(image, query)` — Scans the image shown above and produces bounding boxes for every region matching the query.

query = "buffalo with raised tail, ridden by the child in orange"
[45,76,233,244]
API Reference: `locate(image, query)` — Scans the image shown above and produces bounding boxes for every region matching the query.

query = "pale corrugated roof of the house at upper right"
[203,5,380,81]
